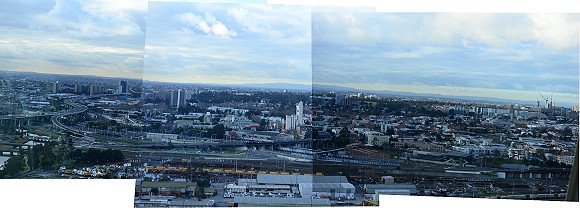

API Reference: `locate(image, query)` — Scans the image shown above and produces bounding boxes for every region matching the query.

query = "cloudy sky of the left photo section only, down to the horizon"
[0,0,147,78]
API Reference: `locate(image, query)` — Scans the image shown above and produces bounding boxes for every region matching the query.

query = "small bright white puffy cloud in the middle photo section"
[178,12,237,38]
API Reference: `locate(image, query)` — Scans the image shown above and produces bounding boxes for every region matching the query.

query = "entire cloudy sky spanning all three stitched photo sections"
[0,0,580,104]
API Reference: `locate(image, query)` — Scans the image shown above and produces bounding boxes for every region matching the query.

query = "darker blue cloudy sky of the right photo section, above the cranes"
[312,12,580,105]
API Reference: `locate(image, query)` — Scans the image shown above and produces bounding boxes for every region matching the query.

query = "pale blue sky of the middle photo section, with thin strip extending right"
[143,2,374,85]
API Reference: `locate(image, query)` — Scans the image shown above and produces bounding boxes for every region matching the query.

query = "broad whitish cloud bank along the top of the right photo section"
[312,12,580,50]
